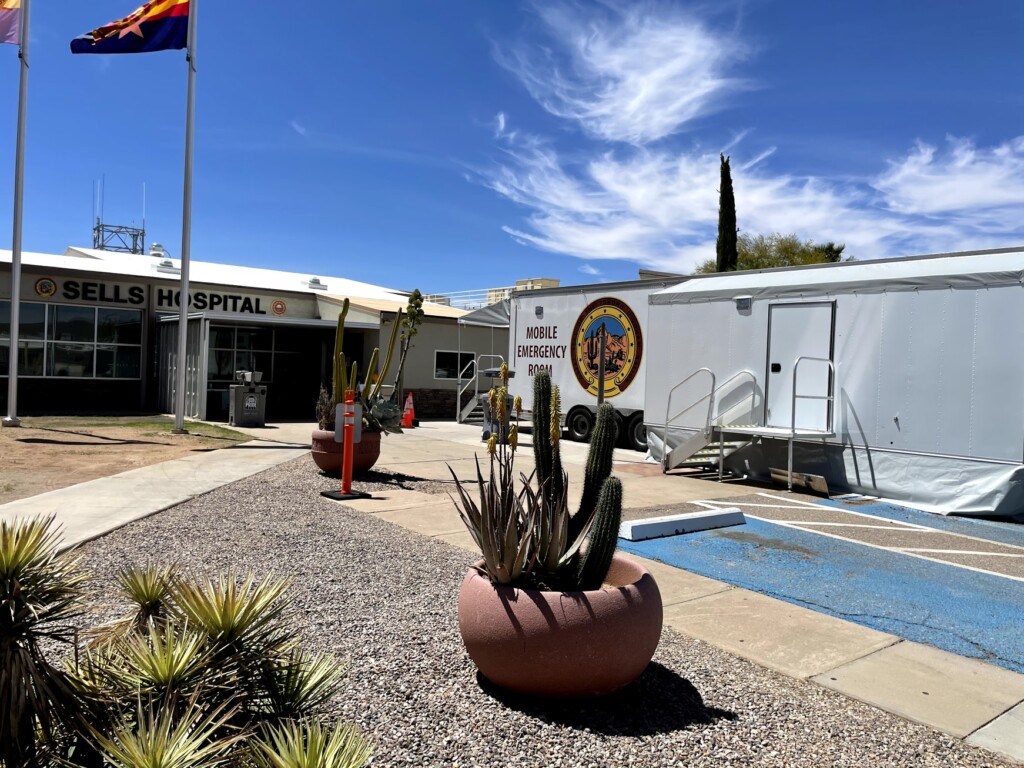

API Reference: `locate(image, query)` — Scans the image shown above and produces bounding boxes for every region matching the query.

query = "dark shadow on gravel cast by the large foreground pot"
[476,662,736,736]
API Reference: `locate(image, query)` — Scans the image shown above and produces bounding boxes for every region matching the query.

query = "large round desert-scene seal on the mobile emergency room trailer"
[571,297,643,397]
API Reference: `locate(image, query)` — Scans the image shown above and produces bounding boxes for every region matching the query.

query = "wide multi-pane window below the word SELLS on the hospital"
[0,301,142,379]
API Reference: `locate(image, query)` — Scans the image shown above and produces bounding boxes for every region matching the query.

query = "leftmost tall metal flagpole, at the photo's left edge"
[3,0,29,427]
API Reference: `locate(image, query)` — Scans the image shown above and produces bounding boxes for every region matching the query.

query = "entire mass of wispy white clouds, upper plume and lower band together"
[480,3,1024,271]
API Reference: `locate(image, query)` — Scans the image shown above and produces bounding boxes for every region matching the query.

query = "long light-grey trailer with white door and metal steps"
[646,249,1024,517]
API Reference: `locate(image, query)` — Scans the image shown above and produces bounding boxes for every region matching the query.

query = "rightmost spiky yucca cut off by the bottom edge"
[252,721,373,768]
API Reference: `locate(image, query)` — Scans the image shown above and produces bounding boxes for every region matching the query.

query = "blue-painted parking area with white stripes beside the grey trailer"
[620,494,1024,672]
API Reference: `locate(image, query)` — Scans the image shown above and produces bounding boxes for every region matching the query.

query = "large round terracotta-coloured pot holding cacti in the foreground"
[459,555,662,696]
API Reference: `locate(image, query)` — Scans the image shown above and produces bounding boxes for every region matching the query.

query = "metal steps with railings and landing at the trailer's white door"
[662,356,836,490]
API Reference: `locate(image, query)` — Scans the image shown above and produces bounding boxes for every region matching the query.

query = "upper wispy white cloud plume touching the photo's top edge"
[498,1,749,143]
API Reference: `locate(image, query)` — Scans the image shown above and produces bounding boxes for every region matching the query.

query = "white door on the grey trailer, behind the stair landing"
[765,301,836,430]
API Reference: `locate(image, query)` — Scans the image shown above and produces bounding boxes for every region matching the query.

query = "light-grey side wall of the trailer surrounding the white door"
[646,251,1024,516]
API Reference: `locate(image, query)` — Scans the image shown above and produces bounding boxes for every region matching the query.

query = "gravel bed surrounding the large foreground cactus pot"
[70,457,1011,768]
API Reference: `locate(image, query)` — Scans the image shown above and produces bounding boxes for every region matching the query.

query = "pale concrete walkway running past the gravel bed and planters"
[0,422,1024,762]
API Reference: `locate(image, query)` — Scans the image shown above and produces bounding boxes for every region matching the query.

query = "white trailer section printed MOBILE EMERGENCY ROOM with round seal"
[509,279,678,451]
